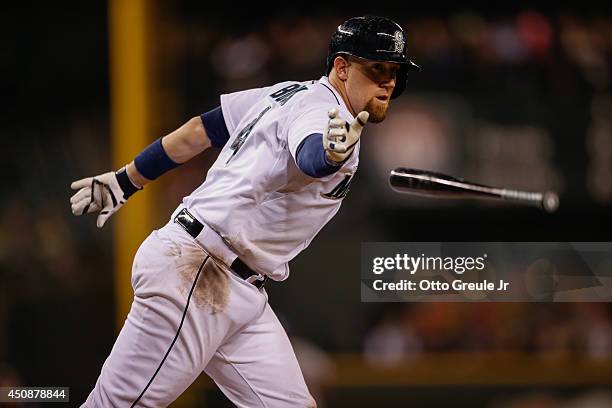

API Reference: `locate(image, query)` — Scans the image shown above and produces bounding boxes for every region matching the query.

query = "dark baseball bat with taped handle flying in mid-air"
[389,167,559,212]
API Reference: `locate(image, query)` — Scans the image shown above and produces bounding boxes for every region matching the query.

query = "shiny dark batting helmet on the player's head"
[327,16,421,99]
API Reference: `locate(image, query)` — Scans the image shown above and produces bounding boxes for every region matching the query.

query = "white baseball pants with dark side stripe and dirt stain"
[83,222,315,408]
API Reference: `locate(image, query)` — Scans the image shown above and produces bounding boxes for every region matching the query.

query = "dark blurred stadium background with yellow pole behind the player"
[0,0,612,408]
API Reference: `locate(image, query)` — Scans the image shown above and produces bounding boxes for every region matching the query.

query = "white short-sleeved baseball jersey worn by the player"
[177,77,359,280]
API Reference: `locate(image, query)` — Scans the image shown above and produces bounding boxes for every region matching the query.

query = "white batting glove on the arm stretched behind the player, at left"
[70,167,142,228]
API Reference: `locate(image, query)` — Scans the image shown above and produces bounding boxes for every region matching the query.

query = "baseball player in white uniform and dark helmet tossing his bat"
[70,16,419,408]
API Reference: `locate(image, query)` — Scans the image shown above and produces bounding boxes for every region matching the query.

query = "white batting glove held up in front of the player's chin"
[323,108,370,164]
